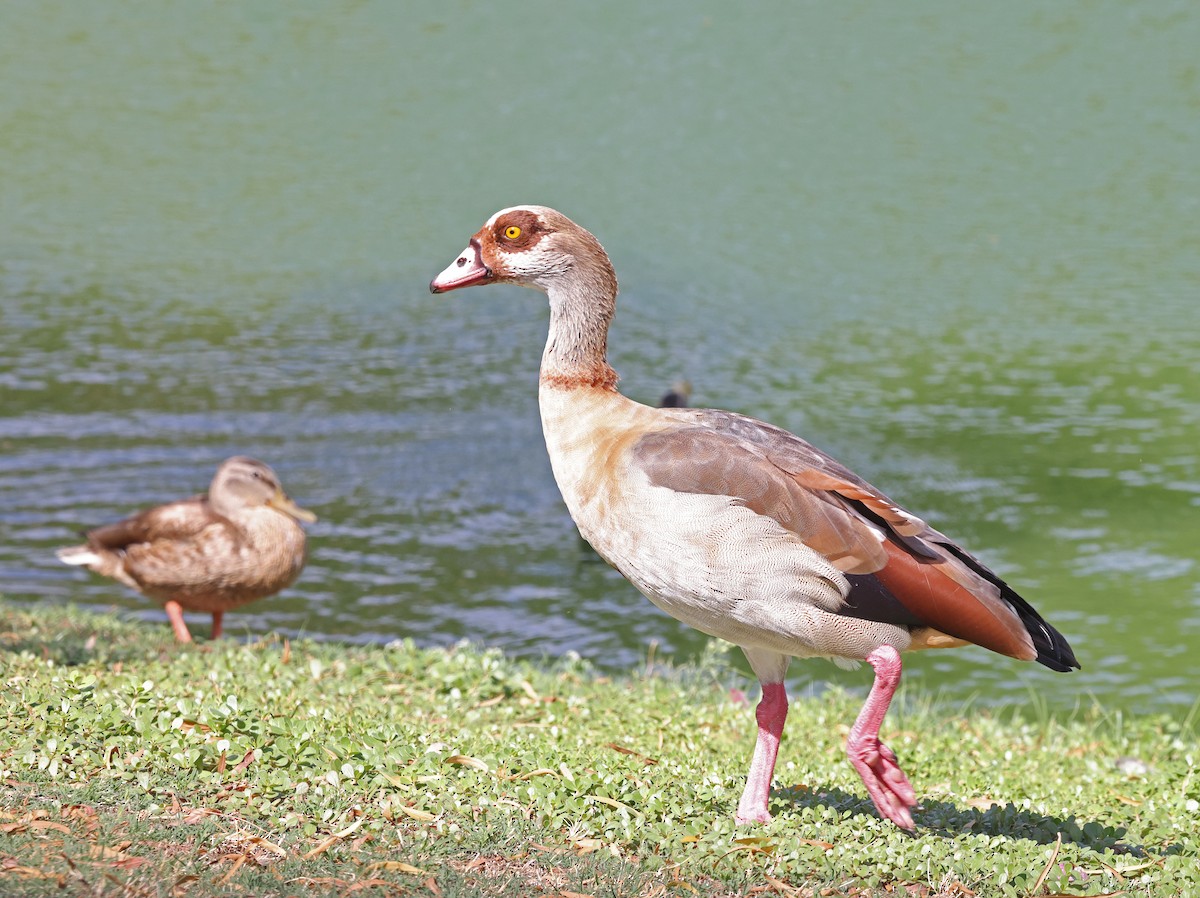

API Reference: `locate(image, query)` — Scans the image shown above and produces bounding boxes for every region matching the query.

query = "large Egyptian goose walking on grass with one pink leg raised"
[430,205,1079,830]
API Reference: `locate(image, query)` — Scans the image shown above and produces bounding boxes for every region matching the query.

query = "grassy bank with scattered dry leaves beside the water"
[0,603,1200,898]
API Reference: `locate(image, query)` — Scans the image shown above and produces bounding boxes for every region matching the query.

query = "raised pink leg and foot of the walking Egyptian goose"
[846,646,917,830]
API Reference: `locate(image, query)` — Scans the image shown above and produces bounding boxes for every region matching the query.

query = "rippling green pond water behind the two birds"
[0,0,1200,713]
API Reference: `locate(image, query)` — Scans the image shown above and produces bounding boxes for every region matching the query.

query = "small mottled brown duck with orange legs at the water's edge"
[58,455,317,642]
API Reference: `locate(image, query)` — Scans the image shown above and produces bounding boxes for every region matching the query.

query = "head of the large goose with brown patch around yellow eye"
[430,205,617,295]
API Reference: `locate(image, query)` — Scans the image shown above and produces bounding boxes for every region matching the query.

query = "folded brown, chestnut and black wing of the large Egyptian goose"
[636,409,1078,670]
